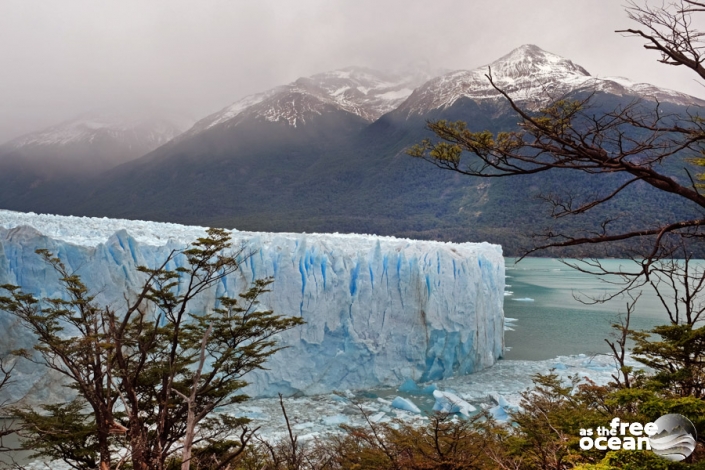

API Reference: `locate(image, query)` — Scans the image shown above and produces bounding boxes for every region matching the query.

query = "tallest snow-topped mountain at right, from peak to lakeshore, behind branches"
[364,45,705,256]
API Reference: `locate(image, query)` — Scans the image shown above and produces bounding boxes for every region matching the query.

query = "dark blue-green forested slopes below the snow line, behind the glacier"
[6,95,700,255]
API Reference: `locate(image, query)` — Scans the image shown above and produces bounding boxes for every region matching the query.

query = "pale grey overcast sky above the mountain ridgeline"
[0,0,705,142]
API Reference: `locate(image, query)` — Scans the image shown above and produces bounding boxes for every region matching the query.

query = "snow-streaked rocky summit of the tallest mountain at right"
[399,44,700,116]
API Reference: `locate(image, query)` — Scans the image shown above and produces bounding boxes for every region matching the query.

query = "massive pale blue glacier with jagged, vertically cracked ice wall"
[0,210,505,401]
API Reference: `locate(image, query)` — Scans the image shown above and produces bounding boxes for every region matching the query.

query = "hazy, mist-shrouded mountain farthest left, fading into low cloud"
[0,110,185,212]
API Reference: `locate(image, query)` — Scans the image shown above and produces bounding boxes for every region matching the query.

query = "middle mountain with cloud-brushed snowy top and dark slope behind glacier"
[20,67,428,221]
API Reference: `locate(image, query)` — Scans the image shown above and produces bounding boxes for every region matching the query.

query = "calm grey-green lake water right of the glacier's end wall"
[504,258,680,360]
